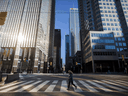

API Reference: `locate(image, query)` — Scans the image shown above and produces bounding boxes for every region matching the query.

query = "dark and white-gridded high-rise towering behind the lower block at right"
[78,0,128,72]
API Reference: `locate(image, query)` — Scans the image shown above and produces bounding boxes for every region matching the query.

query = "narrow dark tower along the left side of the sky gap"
[53,29,61,72]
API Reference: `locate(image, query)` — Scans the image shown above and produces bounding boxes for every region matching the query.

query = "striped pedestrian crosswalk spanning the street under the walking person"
[0,80,128,93]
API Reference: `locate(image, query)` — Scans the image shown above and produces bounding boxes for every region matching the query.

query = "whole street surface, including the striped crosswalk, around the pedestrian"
[0,73,128,96]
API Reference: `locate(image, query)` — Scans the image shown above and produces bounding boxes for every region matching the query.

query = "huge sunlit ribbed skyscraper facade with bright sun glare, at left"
[0,0,55,72]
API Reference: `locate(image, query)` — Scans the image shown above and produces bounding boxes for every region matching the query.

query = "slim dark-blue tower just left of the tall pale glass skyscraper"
[65,35,69,70]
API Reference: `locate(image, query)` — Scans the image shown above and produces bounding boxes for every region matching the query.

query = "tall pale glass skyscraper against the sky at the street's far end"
[69,8,81,56]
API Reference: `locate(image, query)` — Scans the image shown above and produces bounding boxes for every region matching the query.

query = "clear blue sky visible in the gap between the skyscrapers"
[55,0,78,64]
